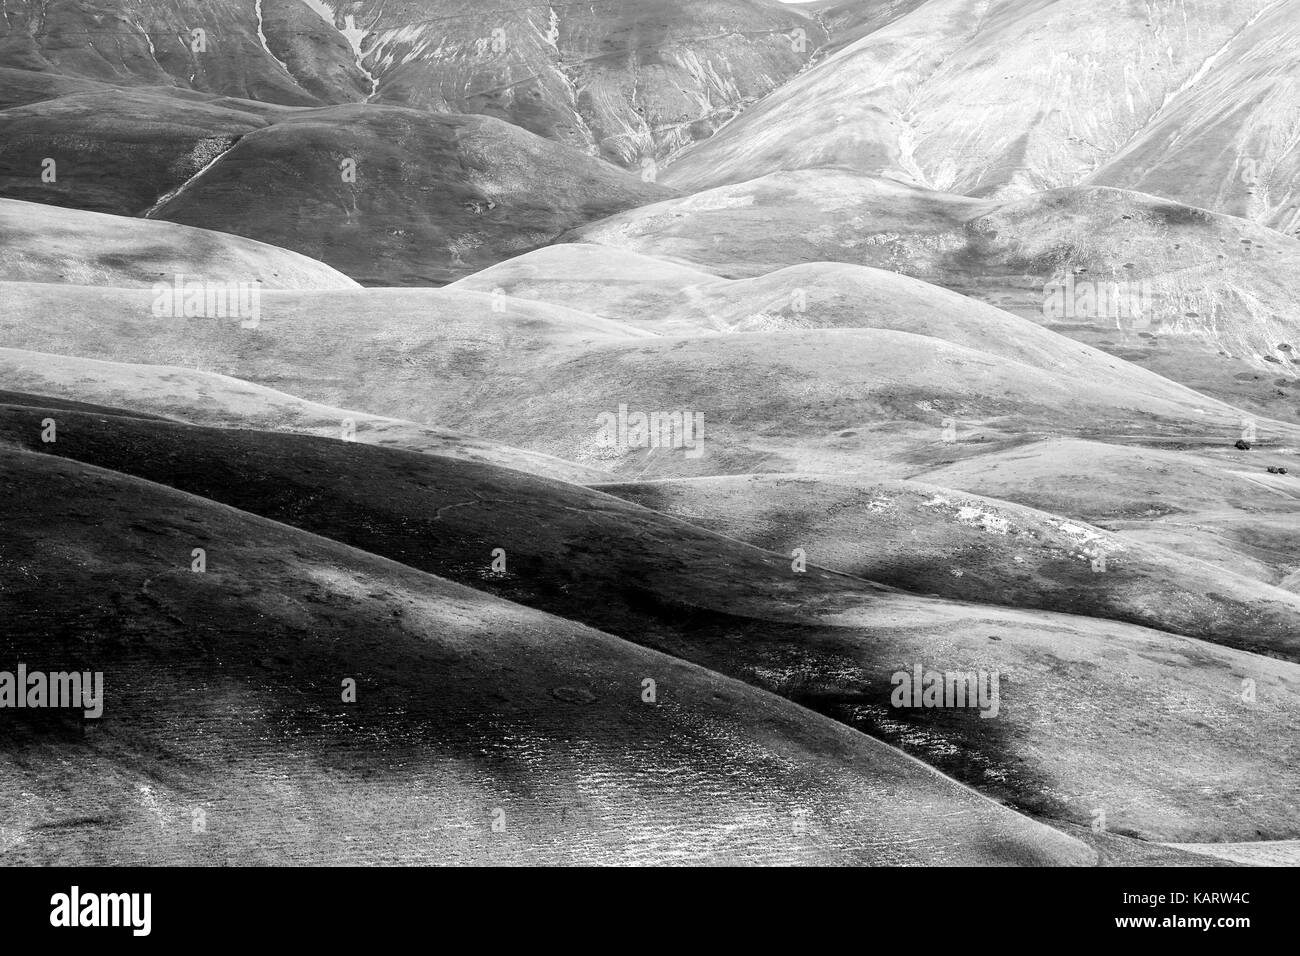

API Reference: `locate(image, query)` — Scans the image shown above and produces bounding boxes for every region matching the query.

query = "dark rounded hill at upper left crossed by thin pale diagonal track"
[0,88,673,285]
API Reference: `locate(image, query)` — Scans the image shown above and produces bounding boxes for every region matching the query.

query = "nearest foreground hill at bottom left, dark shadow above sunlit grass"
[0,450,1095,865]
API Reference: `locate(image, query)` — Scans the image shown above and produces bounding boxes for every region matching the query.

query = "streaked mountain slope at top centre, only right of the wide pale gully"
[296,0,826,166]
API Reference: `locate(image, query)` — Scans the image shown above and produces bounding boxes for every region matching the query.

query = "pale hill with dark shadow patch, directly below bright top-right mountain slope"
[571,169,1300,420]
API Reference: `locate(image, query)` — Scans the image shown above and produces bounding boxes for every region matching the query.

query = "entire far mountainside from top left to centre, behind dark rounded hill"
[0,0,827,166]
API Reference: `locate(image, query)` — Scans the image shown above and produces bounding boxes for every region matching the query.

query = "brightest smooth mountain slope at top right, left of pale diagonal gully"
[664,0,1295,212]
